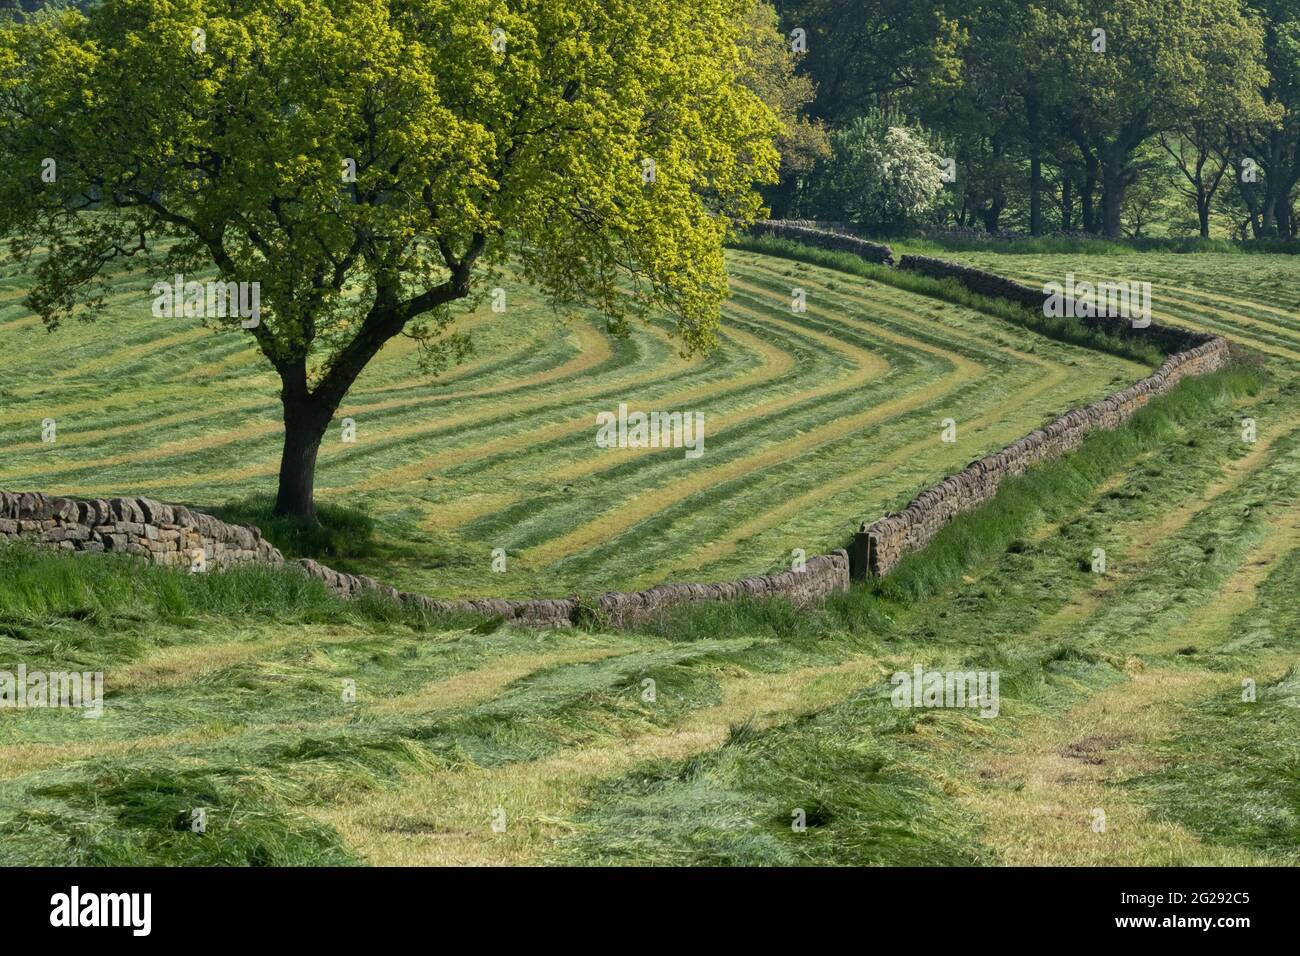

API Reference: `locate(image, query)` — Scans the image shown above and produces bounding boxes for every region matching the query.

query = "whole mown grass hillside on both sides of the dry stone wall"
[0,244,1300,865]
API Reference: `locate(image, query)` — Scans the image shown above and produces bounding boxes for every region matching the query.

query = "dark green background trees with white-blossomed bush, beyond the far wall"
[767,0,1300,238]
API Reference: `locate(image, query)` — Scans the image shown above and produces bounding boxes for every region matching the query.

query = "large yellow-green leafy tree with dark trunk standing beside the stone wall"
[0,0,779,520]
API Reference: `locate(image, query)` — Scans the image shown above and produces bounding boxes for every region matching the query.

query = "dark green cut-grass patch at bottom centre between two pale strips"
[551,695,992,866]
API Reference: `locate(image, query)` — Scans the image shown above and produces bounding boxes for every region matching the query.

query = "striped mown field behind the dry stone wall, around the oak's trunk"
[0,251,1149,597]
